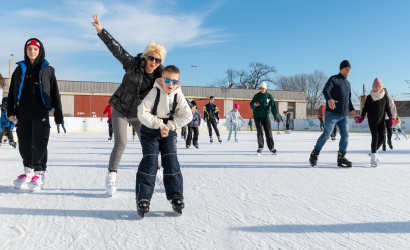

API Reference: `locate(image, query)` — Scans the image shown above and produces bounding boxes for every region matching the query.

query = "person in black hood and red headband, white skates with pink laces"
[7,38,63,191]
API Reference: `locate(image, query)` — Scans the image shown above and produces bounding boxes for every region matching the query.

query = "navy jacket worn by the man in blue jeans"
[323,73,354,116]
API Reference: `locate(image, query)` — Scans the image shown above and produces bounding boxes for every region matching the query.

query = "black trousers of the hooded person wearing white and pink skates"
[16,113,50,171]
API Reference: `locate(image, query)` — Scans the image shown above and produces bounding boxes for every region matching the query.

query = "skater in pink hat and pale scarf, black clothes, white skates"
[355,78,394,167]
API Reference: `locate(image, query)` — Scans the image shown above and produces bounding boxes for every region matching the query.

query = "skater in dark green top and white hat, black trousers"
[250,82,278,154]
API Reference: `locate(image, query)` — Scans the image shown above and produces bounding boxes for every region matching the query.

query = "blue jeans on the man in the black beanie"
[315,111,349,153]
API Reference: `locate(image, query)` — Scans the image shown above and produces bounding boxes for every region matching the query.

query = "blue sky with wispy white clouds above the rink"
[0,0,410,100]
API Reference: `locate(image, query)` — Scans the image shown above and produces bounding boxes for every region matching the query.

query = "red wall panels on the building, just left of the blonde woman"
[74,95,111,117]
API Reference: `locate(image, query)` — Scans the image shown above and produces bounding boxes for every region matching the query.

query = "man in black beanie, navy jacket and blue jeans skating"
[309,60,358,167]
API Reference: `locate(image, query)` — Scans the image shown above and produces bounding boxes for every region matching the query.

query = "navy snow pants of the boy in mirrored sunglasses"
[135,125,184,201]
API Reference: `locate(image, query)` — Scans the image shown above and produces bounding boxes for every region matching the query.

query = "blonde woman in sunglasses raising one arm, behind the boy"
[91,15,166,196]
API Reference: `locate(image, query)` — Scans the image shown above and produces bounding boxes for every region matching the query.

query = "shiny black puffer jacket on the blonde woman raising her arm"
[98,29,164,117]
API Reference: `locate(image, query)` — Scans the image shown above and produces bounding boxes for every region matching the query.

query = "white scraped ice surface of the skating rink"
[0,128,410,249]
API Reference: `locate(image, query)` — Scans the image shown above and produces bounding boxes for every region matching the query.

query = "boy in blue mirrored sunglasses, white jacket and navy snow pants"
[136,65,193,217]
